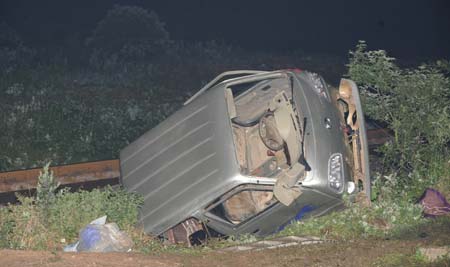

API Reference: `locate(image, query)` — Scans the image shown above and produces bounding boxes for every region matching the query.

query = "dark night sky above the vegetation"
[0,0,450,58]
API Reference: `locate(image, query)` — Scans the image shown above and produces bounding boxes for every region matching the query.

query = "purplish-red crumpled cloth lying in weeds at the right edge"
[419,188,450,217]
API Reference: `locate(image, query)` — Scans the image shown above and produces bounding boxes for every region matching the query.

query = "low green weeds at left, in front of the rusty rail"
[0,165,143,249]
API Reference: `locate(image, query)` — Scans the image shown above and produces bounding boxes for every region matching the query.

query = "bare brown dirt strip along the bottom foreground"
[0,239,446,267]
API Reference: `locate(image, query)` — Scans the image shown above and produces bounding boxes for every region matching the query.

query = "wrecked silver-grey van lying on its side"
[120,70,370,246]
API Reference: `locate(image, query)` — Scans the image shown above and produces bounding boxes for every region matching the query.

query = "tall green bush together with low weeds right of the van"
[283,42,450,242]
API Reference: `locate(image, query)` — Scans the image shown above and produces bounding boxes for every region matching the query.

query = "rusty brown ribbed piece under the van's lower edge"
[166,218,203,246]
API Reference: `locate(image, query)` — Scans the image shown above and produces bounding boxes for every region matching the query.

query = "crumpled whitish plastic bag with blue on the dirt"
[64,216,133,252]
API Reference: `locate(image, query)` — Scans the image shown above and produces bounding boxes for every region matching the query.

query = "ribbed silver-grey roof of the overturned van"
[120,88,243,234]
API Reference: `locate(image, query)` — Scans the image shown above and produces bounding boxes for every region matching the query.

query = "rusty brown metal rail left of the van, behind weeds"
[0,160,120,193]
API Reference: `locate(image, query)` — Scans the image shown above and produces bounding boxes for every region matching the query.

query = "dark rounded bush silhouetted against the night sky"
[86,5,169,66]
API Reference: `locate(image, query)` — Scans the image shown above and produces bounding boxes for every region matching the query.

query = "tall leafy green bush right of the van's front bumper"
[348,42,450,200]
